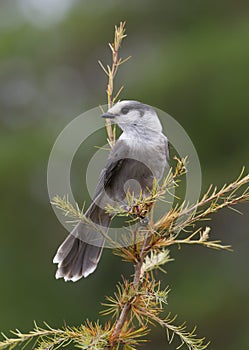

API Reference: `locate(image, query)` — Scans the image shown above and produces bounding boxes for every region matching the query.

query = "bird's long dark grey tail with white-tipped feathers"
[53,206,110,282]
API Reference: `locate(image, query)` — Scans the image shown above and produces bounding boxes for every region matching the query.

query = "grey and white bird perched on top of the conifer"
[53,100,169,282]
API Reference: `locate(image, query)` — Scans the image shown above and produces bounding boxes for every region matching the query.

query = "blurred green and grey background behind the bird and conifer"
[0,0,249,350]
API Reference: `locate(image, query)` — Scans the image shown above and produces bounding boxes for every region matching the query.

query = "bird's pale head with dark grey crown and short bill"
[102,101,162,132]
